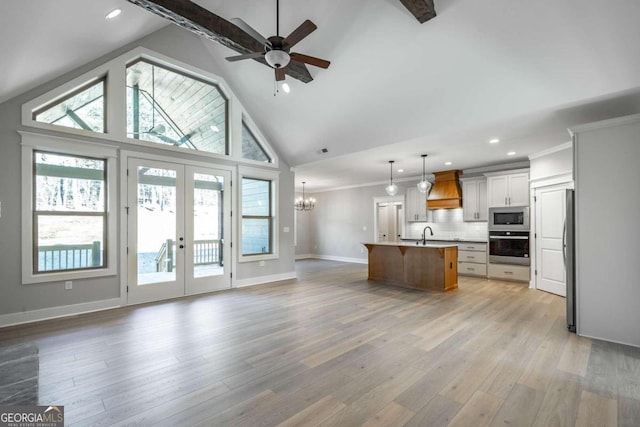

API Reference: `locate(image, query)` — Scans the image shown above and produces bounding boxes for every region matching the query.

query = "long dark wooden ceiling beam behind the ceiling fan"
[128,0,313,83]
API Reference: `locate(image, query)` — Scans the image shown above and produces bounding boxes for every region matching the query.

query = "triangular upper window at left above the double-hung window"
[33,78,106,133]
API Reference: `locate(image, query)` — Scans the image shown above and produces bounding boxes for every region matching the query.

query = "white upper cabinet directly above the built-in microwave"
[486,169,529,207]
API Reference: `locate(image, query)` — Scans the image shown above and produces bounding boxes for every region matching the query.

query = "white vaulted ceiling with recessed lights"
[0,0,640,191]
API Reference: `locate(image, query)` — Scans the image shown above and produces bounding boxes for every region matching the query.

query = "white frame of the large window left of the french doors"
[20,132,118,284]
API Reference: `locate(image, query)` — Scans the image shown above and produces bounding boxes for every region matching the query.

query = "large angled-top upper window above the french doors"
[127,60,229,155]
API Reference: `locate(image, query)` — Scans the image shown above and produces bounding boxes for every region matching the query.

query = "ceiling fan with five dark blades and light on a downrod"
[226,0,331,81]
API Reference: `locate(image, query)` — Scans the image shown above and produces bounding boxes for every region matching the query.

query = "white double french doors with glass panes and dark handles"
[127,157,231,304]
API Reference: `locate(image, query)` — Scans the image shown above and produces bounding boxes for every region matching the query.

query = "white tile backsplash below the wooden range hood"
[404,208,488,241]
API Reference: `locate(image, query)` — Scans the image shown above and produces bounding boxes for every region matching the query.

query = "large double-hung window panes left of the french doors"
[33,150,107,274]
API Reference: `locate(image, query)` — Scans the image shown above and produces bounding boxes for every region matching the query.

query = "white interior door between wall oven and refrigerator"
[535,186,568,296]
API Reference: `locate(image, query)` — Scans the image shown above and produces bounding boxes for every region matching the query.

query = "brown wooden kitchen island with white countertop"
[363,242,458,292]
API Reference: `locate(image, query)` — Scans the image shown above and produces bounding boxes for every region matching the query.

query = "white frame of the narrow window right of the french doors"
[234,166,280,262]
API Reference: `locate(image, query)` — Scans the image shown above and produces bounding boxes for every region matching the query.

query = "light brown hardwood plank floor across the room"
[0,260,640,426]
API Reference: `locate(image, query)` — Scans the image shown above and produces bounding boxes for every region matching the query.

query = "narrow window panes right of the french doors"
[242,177,273,255]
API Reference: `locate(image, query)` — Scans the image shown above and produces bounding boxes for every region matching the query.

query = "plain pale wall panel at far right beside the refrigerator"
[574,116,640,346]
